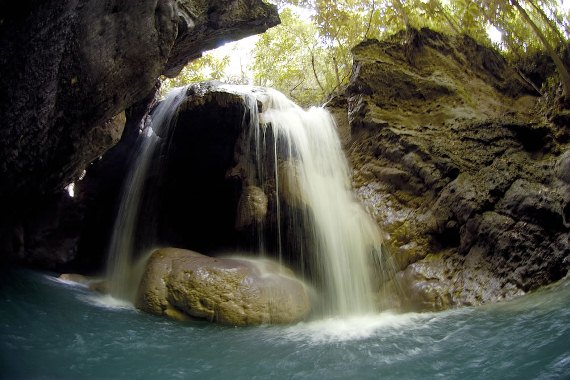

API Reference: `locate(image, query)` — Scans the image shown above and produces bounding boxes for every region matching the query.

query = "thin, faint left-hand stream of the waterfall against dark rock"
[107,87,186,301]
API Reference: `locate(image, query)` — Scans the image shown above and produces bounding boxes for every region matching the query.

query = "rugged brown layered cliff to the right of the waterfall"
[330,30,570,309]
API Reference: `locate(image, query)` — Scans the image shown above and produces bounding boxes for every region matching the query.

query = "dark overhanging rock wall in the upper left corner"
[0,0,279,268]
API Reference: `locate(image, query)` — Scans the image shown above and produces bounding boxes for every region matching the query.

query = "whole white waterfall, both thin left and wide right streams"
[109,85,381,315]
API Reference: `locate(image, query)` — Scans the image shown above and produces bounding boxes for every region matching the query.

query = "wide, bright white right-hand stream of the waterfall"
[227,86,382,315]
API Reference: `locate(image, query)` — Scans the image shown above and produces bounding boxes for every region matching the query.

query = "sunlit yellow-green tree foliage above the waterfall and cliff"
[163,0,570,106]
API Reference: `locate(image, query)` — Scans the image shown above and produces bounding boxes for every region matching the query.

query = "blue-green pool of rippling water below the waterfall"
[0,271,570,380]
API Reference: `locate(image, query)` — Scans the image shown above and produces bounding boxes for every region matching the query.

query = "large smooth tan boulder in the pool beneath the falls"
[136,248,310,326]
